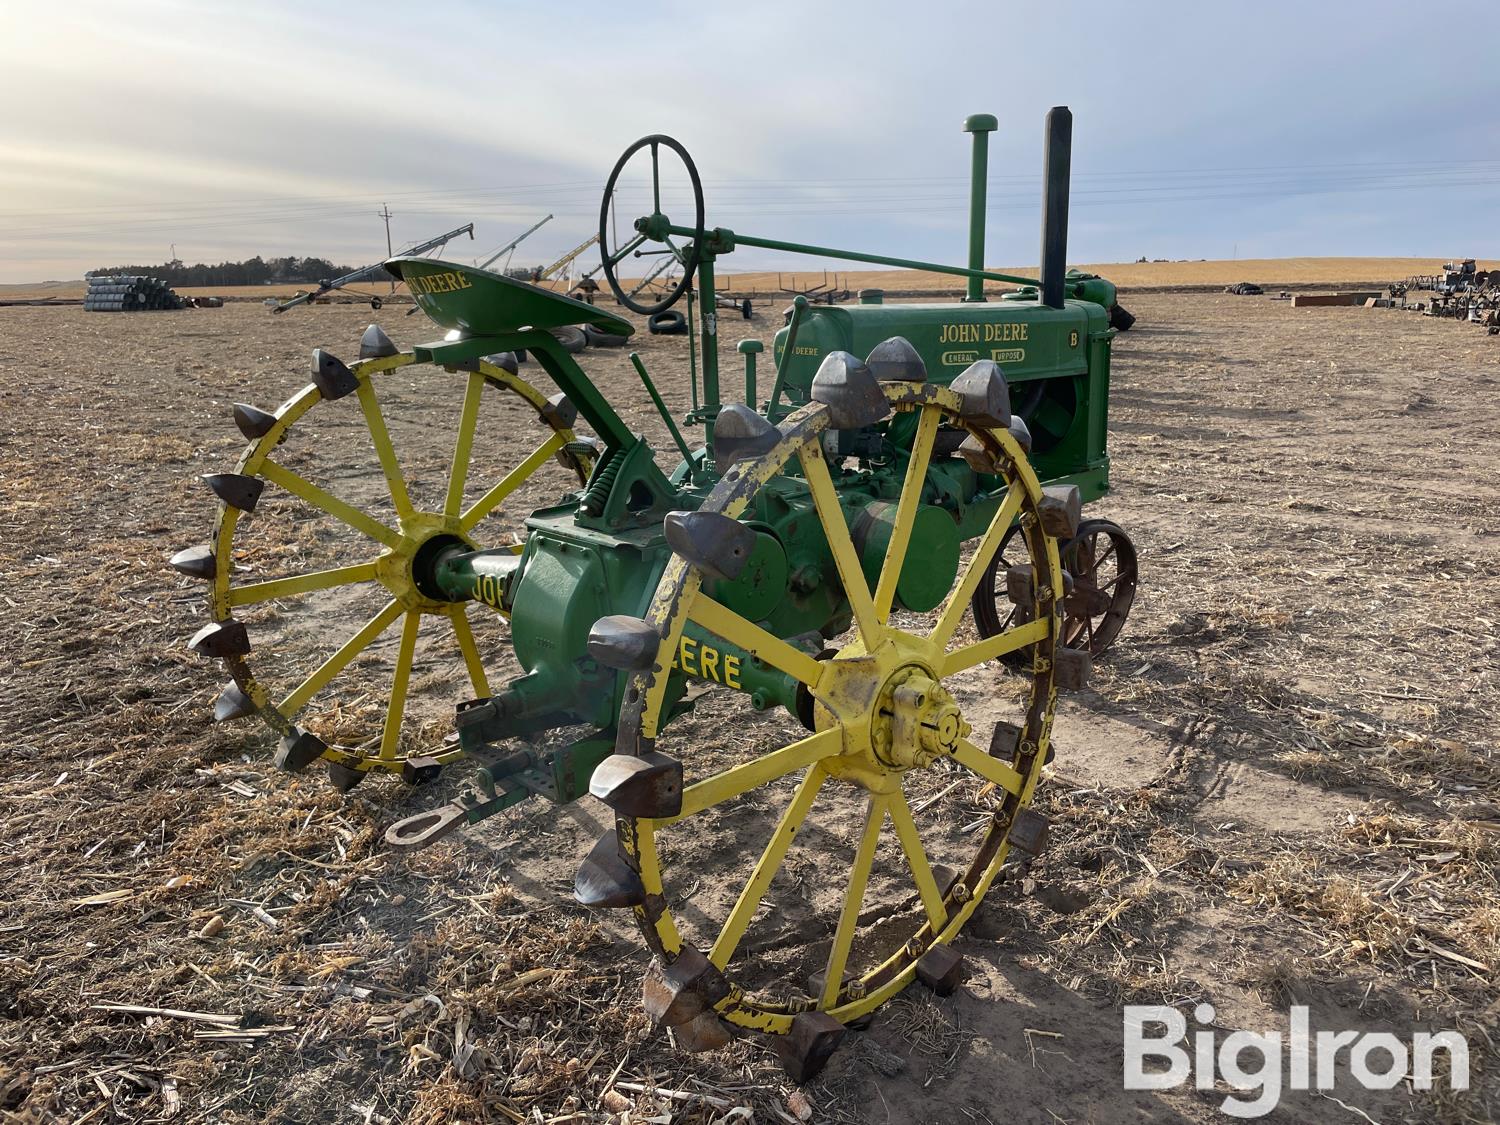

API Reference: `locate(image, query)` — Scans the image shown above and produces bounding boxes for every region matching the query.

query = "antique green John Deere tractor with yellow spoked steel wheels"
[173,108,1136,1080]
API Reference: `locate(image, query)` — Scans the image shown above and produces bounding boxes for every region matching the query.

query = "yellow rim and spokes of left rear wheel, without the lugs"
[210,353,593,777]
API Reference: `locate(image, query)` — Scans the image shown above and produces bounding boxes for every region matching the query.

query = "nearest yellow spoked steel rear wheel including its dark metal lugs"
[603,384,1076,1079]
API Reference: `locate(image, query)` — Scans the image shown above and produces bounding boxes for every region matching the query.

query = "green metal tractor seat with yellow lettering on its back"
[386,258,636,338]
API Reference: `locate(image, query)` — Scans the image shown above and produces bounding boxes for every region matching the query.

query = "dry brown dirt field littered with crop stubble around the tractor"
[0,291,1500,1125]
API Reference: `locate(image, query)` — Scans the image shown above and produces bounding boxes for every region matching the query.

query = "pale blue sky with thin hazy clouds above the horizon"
[0,0,1500,282]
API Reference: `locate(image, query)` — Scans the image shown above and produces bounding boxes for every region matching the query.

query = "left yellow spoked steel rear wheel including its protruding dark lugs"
[174,330,593,789]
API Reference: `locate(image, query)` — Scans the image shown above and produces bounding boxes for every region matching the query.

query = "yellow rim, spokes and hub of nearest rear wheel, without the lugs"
[617,386,1062,1034]
